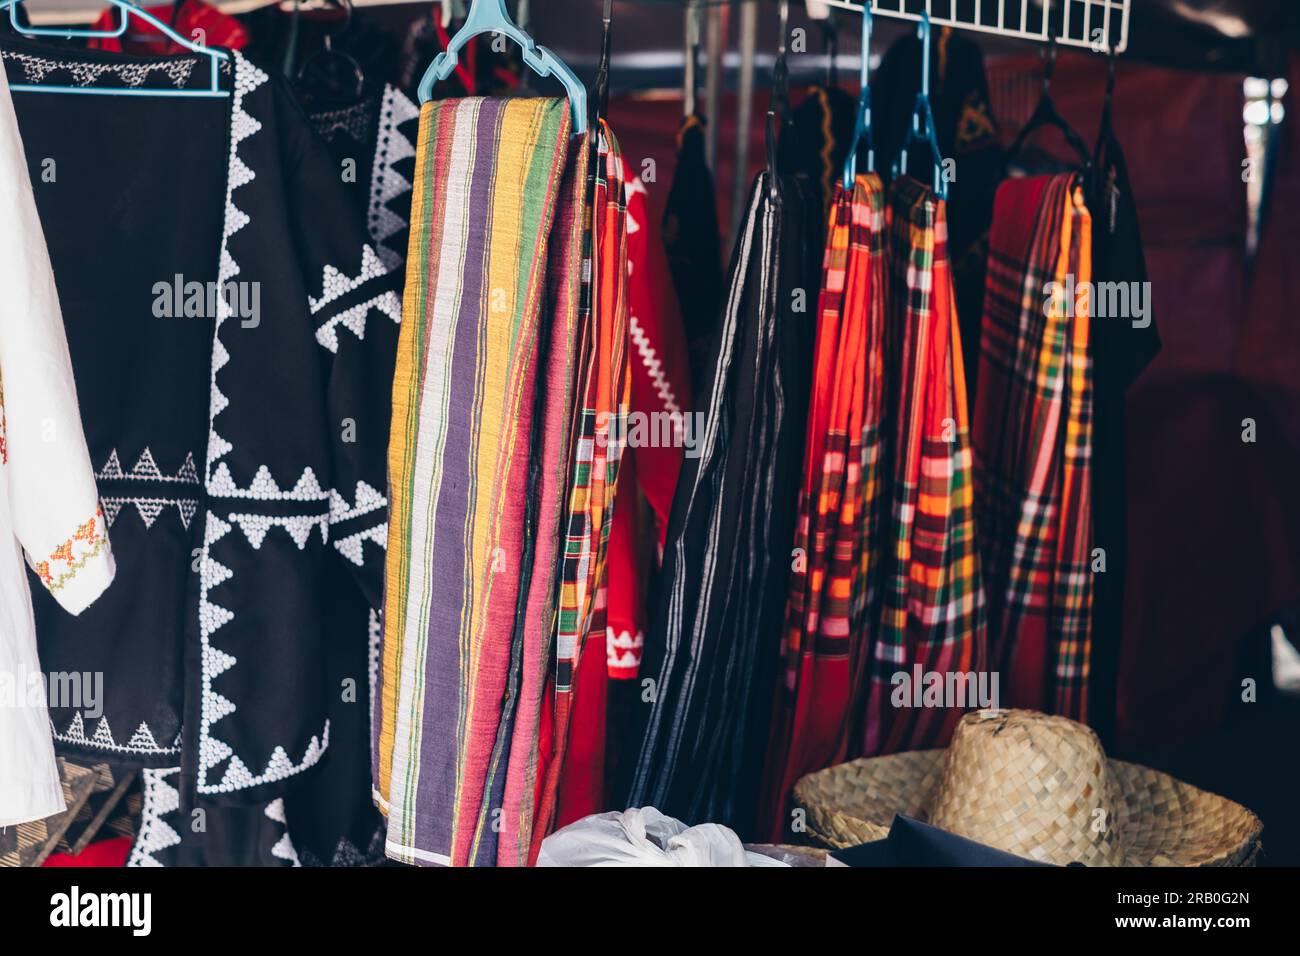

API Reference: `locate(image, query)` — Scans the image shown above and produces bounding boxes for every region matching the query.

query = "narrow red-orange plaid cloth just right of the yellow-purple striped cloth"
[532,120,632,858]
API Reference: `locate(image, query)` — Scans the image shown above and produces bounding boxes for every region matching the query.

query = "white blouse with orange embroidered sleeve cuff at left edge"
[0,69,114,826]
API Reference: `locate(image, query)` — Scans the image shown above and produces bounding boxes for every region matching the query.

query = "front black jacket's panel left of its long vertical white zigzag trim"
[0,38,229,766]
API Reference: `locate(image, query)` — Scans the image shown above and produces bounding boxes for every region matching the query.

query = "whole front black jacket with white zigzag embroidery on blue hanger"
[0,39,400,806]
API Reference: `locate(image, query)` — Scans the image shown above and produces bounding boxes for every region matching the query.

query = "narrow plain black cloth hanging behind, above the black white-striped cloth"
[663,116,723,394]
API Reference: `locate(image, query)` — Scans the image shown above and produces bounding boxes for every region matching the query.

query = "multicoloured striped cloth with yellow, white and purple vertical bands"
[376,99,569,865]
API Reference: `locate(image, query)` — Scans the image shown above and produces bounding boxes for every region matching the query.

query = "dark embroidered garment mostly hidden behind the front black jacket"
[279,86,420,866]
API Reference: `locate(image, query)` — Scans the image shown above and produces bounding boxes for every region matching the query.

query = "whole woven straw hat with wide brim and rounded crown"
[794,710,1264,866]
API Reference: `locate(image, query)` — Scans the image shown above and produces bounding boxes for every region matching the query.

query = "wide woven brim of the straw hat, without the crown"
[794,750,1264,866]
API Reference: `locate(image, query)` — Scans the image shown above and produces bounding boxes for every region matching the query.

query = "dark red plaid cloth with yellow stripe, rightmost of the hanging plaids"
[975,174,1092,721]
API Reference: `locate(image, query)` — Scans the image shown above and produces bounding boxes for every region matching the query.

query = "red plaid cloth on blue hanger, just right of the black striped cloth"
[759,173,891,840]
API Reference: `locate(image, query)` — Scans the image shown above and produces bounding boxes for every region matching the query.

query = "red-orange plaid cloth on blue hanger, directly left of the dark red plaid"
[863,177,987,756]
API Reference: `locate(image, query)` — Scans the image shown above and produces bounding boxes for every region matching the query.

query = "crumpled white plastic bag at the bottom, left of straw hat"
[537,806,788,866]
